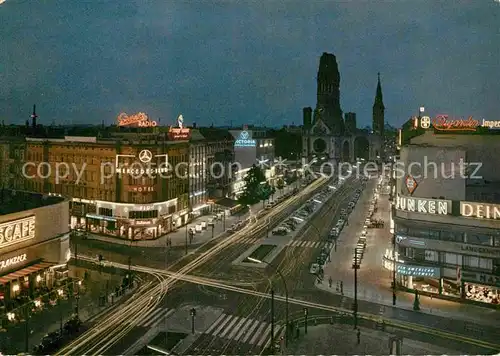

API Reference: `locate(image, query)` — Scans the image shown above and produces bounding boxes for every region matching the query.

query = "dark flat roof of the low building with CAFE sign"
[0,189,64,215]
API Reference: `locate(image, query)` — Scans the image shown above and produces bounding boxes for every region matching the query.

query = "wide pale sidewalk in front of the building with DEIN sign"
[316,177,500,326]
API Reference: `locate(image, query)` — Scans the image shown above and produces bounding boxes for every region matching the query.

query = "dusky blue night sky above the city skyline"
[0,0,500,126]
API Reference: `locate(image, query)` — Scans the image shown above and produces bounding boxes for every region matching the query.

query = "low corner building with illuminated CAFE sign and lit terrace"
[0,189,71,308]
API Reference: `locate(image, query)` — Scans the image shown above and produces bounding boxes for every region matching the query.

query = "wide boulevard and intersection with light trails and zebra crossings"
[58,177,500,355]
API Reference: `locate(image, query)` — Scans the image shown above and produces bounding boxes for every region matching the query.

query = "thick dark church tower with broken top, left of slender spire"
[316,52,344,135]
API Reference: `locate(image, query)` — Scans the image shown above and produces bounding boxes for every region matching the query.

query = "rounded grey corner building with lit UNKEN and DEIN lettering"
[389,121,500,304]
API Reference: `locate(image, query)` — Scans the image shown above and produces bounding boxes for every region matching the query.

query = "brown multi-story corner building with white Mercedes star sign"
[0,121,189,239]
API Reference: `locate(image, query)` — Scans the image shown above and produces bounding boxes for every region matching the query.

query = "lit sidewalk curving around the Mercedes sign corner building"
[87,183,298,247]
